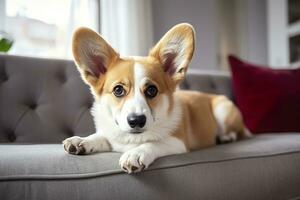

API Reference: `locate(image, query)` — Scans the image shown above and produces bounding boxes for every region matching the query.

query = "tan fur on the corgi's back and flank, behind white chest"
[174,91,245,150]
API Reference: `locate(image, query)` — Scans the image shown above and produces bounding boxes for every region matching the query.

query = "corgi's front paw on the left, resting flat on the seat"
[63,136,93,155]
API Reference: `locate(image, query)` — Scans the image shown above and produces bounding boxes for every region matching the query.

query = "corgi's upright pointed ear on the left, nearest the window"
[72,28,119,85]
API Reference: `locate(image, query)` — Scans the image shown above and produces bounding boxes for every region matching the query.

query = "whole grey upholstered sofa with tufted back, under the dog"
[0,55,300,200]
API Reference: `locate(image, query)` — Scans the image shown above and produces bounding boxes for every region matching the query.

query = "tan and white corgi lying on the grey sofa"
[63,23,248,173]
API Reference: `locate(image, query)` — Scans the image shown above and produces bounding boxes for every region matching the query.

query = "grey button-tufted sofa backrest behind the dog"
[0,54,232,143]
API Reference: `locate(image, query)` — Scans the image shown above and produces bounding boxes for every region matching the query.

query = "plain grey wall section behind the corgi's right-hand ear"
[152,0,218,69]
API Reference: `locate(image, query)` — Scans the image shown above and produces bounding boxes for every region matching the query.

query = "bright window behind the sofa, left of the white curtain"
[0,0,99,58]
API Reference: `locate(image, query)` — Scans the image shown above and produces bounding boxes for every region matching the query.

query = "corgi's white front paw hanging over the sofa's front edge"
[119,148,154,174]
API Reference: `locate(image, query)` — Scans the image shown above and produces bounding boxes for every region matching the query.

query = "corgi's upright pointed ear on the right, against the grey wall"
[149,23,195,84]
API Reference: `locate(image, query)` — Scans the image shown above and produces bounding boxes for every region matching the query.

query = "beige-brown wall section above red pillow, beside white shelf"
[219,0,268,68]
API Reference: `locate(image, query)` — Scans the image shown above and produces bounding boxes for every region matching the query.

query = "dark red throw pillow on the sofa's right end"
[229,56,300,133]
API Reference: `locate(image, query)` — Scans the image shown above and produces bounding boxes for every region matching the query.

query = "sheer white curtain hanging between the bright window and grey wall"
[100,0,153,56]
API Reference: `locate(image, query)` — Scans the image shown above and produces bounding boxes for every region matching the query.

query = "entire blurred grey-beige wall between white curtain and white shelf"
[152,0,268,70]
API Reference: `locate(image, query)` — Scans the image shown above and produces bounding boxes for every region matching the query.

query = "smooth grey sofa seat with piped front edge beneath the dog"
[0,133,300,199]
